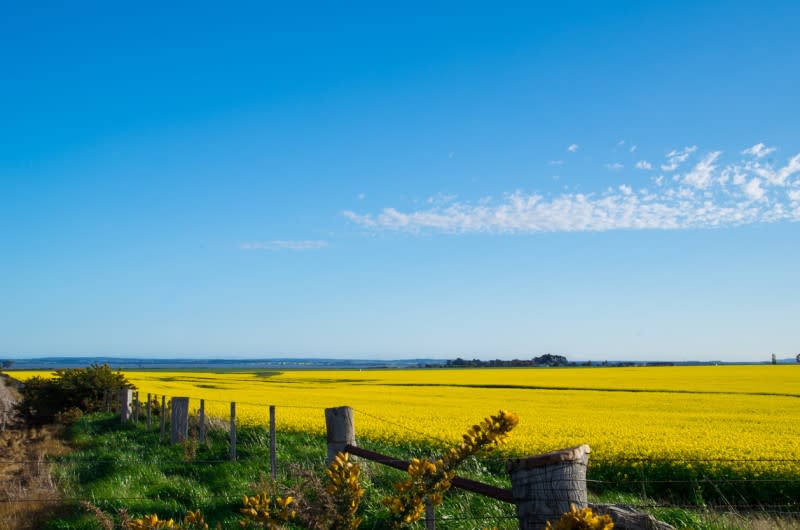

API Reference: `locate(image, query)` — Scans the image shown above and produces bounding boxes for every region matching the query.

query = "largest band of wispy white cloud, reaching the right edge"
[343,146,800,233]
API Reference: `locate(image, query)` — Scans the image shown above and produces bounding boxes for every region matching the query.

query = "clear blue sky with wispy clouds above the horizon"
[0,2,800,360]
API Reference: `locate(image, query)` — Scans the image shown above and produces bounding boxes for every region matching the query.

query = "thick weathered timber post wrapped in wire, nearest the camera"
[506,444,591,530]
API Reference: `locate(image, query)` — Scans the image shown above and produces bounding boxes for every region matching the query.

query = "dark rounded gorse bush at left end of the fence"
[16,364,134,425]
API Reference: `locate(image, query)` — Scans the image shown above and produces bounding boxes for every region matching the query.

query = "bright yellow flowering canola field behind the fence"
[16,365,800,473]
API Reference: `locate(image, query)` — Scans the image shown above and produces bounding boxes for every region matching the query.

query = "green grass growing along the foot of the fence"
[45,414,795,530]
